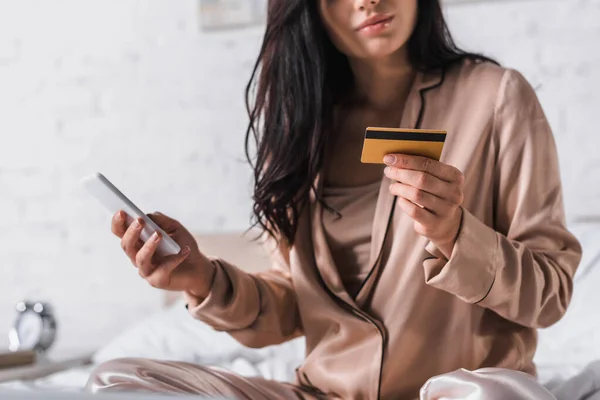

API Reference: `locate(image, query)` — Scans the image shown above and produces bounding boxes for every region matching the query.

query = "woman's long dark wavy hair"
[246,0,491,244]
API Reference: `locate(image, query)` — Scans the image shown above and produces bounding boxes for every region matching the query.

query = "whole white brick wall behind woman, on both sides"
[0,0,600,356]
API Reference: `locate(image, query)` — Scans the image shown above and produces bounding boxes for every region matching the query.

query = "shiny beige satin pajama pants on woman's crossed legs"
[86,358,555,400]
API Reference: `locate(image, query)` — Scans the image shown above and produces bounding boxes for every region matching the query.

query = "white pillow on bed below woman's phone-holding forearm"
[94,299,305,381]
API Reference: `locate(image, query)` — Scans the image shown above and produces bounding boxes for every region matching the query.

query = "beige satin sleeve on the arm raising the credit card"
[423,70,581,328]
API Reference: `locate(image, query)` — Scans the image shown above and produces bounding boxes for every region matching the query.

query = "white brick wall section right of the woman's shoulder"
[449,0,600,219]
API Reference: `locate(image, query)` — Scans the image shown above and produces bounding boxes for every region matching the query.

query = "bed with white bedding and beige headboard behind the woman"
[0,225,600,400]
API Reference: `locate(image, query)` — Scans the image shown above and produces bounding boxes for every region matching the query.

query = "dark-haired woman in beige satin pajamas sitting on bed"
[88,0,581,399]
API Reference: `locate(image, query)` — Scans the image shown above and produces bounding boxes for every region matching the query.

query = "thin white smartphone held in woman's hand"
[81,172,181,256]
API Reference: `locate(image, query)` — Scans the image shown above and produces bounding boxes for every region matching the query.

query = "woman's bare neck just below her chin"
[349,51,415,111]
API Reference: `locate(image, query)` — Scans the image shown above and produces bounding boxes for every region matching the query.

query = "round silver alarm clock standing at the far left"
[8,300,56,352]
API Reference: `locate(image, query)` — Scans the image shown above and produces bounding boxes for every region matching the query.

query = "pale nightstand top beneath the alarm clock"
[0,354,92,383]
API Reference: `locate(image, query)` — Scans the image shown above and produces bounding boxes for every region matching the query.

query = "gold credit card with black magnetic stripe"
[360,128,446,164]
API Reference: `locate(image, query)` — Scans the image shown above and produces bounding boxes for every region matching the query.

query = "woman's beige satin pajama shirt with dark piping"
[188,62,581,399]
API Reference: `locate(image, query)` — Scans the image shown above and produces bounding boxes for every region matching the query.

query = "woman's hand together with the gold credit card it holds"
[361,128,464,258]
